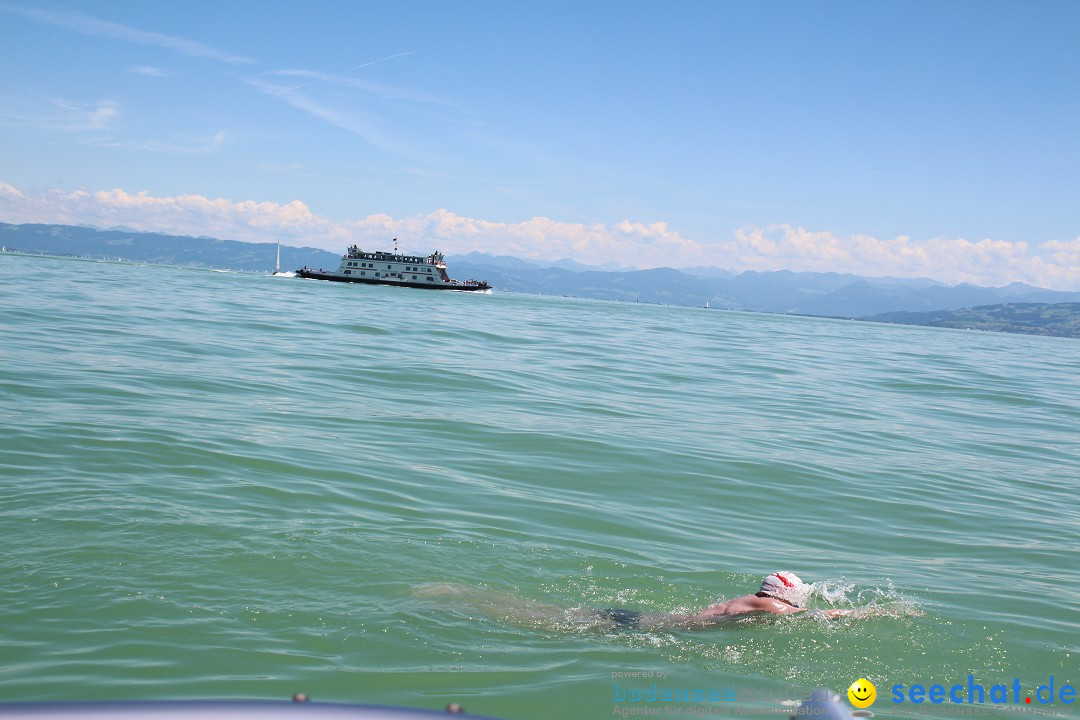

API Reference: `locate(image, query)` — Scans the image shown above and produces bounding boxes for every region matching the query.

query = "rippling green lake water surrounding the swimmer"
[0,255,1080,720]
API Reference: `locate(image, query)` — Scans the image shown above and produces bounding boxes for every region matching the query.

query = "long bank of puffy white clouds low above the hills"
[0,182,1080,289]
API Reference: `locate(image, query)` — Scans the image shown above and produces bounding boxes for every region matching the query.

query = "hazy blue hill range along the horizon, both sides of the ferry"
[6,223,1080,322]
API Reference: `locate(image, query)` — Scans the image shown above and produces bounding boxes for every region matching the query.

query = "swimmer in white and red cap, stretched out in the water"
[414,571,853,630]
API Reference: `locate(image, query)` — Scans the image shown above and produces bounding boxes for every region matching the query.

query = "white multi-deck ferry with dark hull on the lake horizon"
[296,237,491,293]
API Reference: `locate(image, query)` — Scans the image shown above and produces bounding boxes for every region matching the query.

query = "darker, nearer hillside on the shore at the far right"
[860,302,1080,338]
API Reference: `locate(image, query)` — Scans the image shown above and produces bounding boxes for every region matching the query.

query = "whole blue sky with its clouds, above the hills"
[0,0,1080,289]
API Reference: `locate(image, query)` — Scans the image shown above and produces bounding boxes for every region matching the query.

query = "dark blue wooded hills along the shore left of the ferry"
[0,222,340,272]
